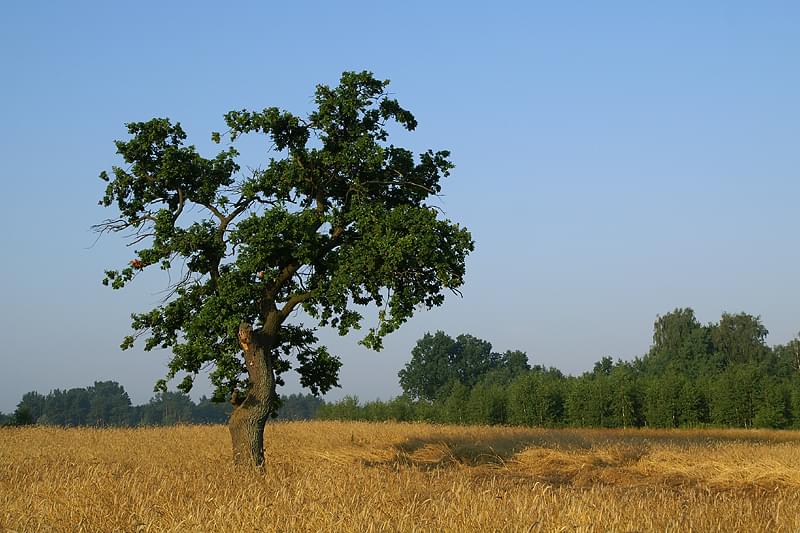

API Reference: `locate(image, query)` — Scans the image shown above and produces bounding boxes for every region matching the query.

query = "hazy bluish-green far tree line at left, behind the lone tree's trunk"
[0,381,322,427]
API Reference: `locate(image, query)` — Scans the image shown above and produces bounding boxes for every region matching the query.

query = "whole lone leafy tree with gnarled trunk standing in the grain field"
[95,72,473,466]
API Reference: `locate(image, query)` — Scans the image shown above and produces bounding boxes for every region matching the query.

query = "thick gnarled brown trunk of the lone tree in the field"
[228,323,275,467]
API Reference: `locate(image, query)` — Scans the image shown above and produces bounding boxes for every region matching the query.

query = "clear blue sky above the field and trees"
[0,0,800,412]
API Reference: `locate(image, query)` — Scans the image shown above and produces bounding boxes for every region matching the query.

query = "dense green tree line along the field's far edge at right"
[318,308,800,428]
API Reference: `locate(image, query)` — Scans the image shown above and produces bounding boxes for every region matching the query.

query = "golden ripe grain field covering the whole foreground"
[0,422,800,532]
